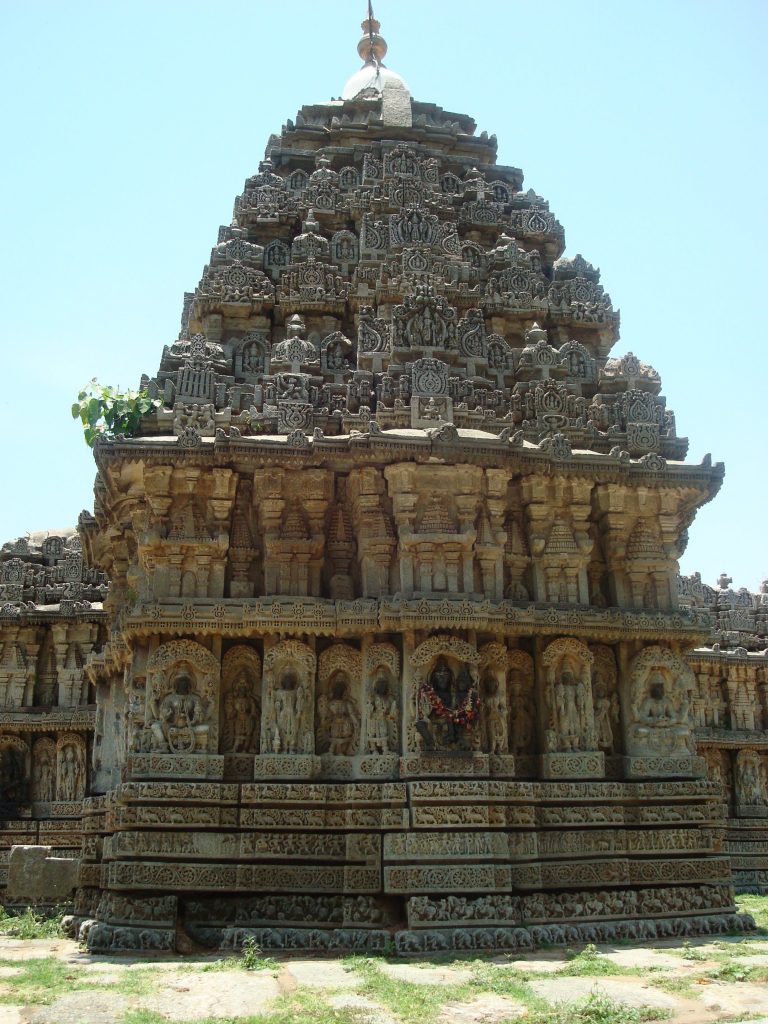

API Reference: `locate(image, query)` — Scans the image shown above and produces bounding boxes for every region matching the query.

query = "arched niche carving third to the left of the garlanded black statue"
[261,640,316,754]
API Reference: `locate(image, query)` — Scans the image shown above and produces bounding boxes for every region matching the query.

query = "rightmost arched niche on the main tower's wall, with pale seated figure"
[627,646,696,755]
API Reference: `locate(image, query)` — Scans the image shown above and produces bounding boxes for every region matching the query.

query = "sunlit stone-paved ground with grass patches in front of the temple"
[0,935,768,1024]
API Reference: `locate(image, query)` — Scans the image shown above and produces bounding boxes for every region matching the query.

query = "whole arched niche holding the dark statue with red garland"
[409,635,480,753]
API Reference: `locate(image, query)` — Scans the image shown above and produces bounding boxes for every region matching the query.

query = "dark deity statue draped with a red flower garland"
[416,657,480,752]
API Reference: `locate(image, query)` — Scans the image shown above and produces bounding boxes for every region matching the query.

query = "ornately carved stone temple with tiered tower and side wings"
[0,14,768,953]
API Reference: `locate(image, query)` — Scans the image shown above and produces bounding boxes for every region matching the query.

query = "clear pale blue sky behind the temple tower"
[0,0,768,589]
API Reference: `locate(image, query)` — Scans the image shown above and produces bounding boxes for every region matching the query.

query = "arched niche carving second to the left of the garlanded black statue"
[314,643,362,757]
